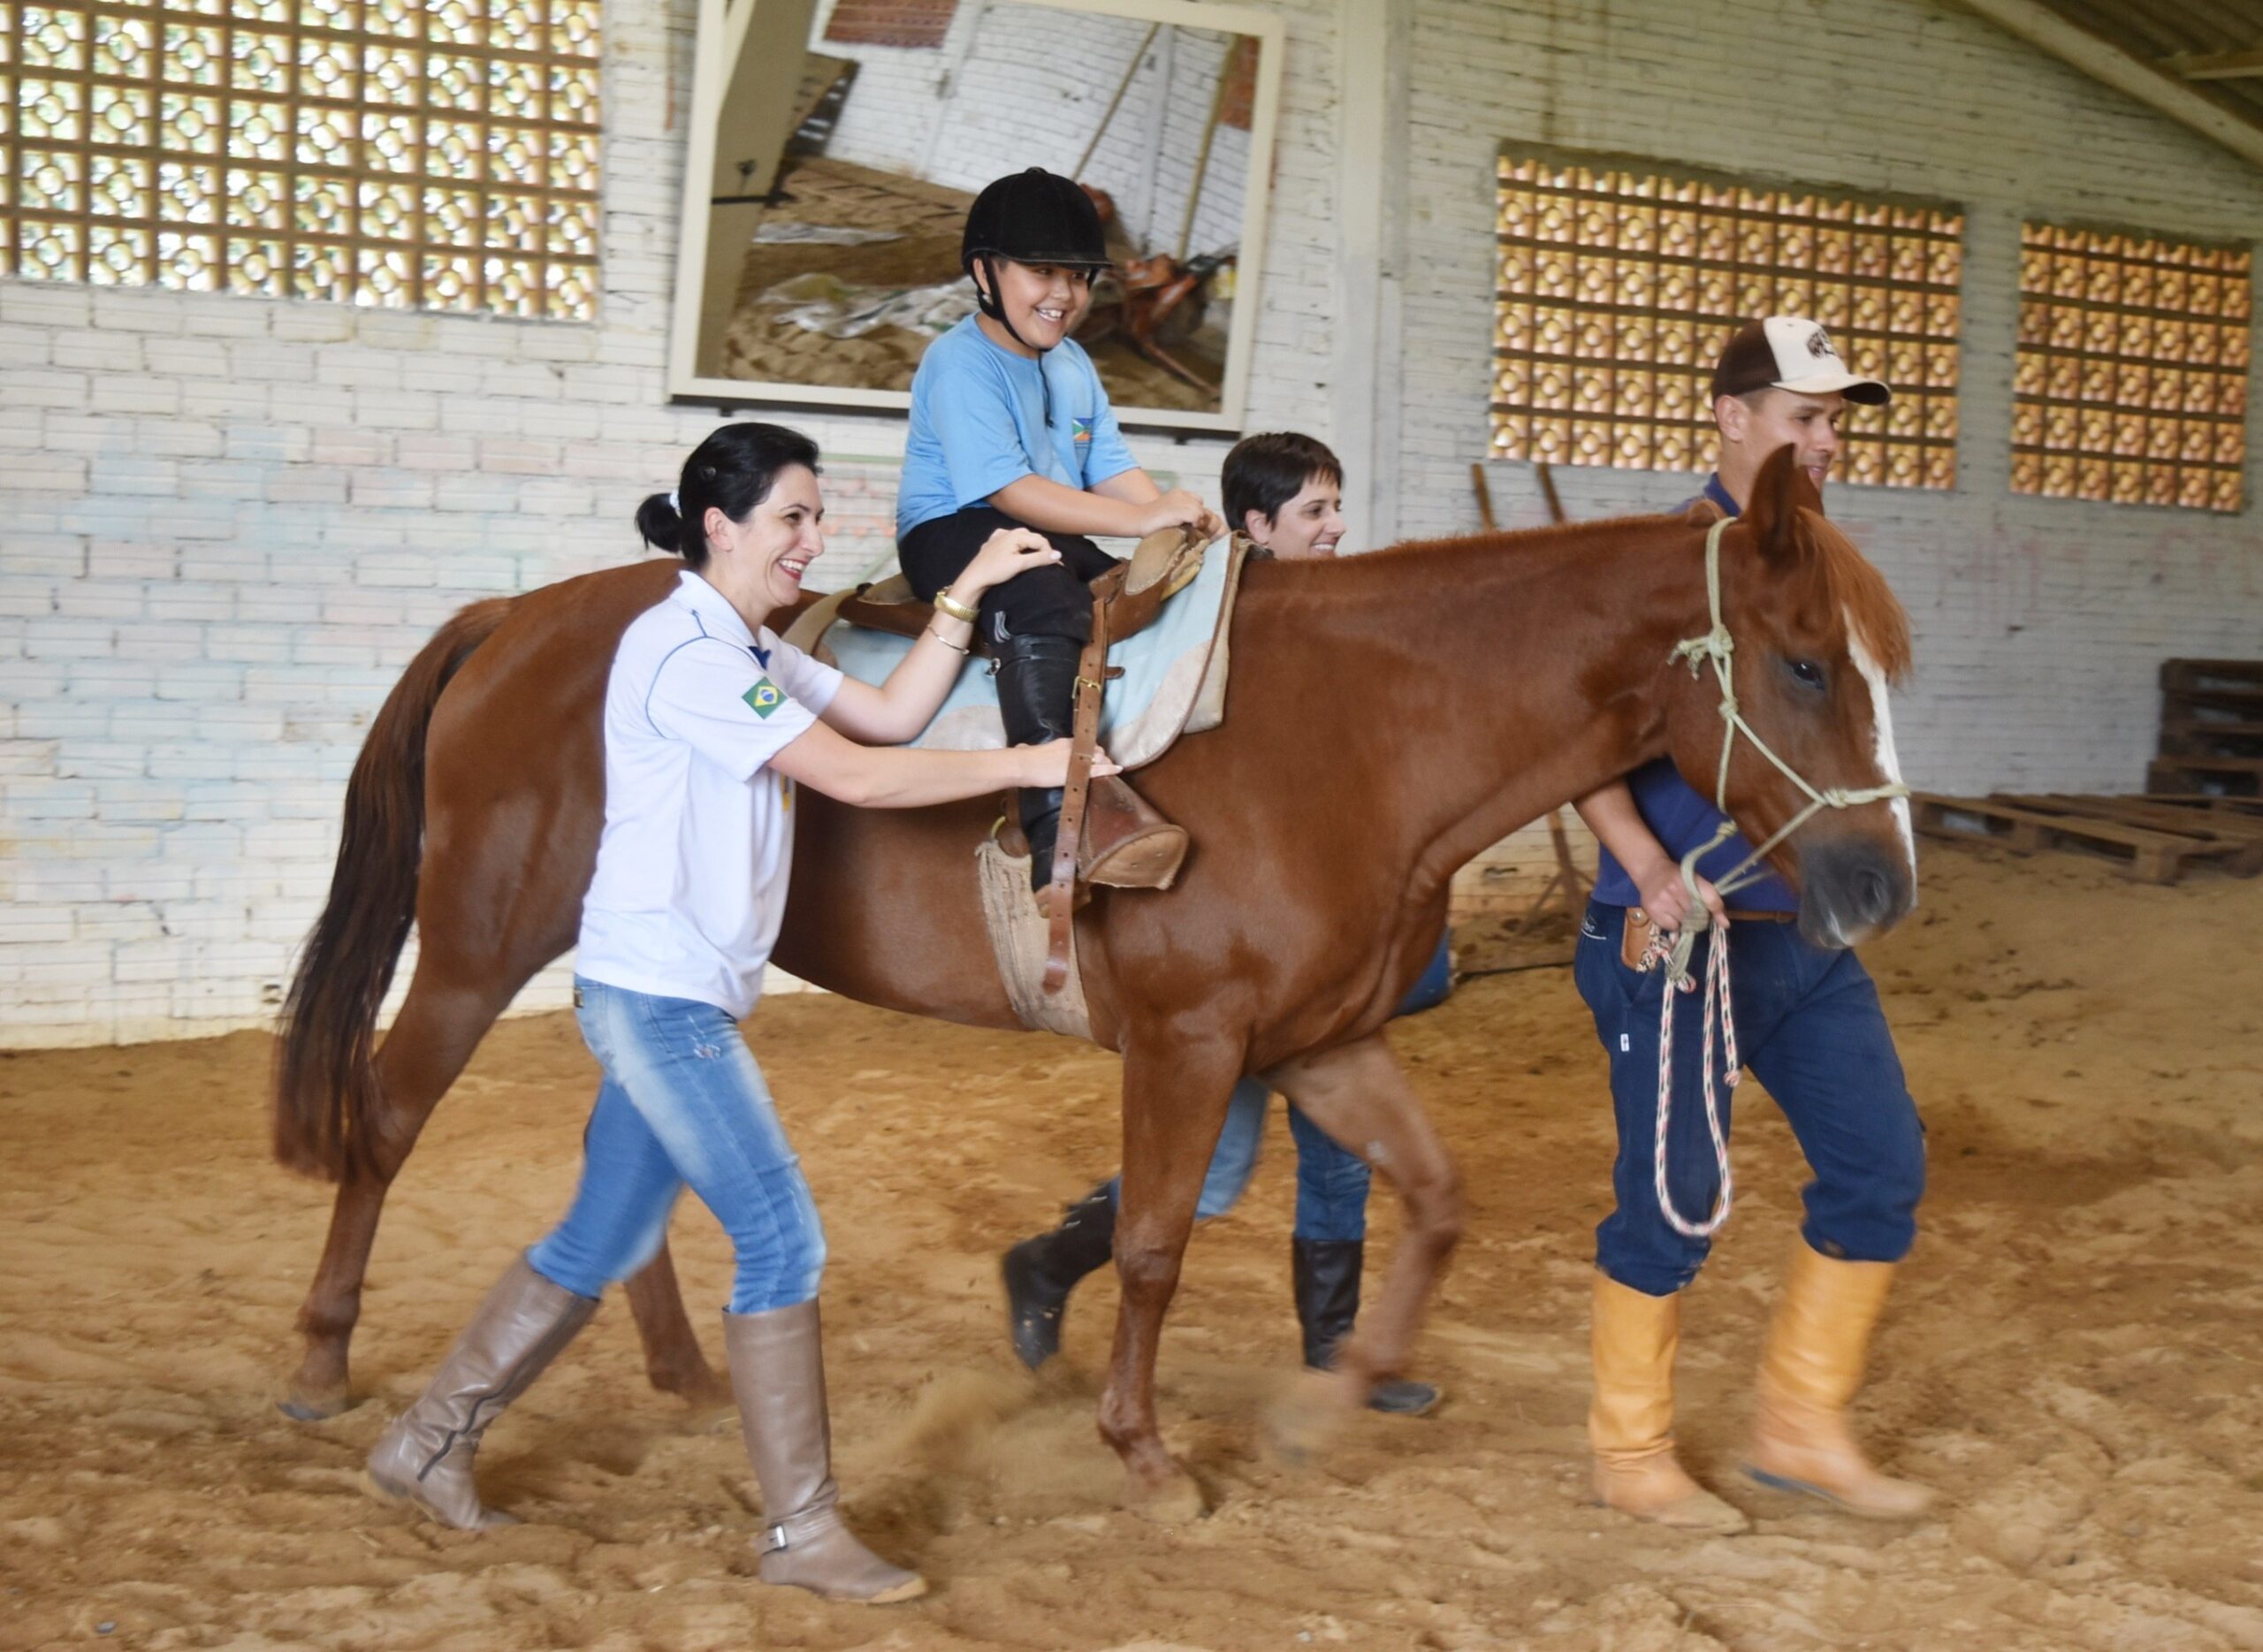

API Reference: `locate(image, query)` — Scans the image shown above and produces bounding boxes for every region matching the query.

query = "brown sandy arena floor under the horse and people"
[0,849,2263,1652]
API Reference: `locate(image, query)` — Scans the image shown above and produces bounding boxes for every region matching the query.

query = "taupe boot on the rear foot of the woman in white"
[369,1256,598,1532]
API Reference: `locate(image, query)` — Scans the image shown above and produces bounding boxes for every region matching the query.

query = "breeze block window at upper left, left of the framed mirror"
[0,0,602,322]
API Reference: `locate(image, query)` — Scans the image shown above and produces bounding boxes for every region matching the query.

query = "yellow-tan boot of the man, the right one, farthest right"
[1745,1240,1932,1521]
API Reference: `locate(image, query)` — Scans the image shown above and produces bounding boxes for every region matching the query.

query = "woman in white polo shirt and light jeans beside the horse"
[369,423,1104,1603]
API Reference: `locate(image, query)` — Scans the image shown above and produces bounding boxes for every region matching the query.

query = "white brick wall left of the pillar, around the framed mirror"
[0,0,1335,1046]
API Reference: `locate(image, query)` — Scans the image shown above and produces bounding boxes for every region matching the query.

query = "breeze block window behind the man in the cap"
[1491,147,1964,486]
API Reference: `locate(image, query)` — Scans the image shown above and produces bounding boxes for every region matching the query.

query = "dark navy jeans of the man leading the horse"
[1573,901,1926,1297]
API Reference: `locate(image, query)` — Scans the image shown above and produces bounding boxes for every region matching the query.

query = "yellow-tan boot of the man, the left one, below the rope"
[1587,1272,1749,1534]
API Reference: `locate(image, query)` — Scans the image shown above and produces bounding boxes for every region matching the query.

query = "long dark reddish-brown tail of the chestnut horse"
[274,598,512,1181]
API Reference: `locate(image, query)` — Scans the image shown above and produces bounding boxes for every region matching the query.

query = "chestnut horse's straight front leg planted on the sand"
[1100,1030,1245,1521]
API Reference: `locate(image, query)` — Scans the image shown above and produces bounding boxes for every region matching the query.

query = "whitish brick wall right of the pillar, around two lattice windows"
[1397,0,2263,900]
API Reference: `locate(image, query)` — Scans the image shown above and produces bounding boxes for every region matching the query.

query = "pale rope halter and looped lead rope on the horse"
[1643,516,1910,1237]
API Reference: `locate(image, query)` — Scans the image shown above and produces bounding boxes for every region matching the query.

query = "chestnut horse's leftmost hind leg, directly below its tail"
[280,966,516,1421]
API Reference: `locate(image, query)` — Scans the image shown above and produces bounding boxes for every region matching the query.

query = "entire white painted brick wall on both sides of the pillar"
[0,0,2263,1043]
